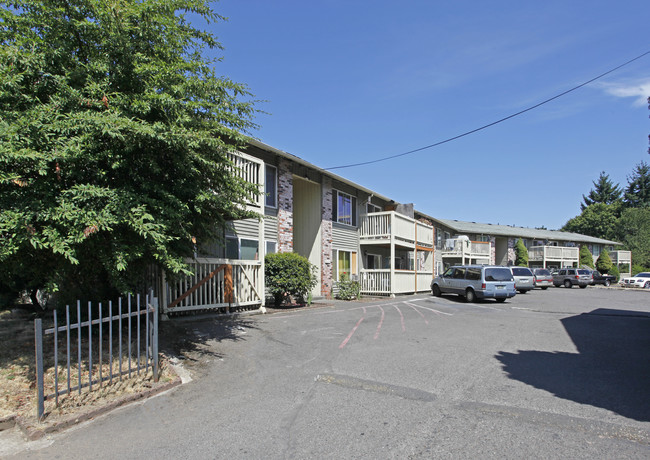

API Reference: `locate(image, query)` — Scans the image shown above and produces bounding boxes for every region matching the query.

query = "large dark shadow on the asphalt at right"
[496,309,650,421]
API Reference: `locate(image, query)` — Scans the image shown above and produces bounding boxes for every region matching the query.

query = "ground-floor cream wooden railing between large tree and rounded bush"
[162,258,264,313]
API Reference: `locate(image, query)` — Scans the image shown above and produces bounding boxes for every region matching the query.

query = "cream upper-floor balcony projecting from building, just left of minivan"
[359,211,433,248]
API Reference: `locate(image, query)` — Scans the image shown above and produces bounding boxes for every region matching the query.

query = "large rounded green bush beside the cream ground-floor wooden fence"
[264,252,317,307]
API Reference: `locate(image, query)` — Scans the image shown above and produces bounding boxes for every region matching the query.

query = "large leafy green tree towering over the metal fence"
[0,0,255,304]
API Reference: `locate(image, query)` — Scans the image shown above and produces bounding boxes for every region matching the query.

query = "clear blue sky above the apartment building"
[210,0,650,229]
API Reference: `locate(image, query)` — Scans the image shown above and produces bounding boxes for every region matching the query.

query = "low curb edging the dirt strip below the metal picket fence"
[13,376,181,441]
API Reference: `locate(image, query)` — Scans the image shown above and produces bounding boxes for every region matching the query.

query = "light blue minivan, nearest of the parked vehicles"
[431,265,517,302]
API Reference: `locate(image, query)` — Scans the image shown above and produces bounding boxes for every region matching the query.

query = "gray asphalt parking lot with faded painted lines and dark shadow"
[5,287,650,459]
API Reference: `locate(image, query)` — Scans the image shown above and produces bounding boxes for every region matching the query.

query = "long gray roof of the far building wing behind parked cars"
[432,218,621,245]
